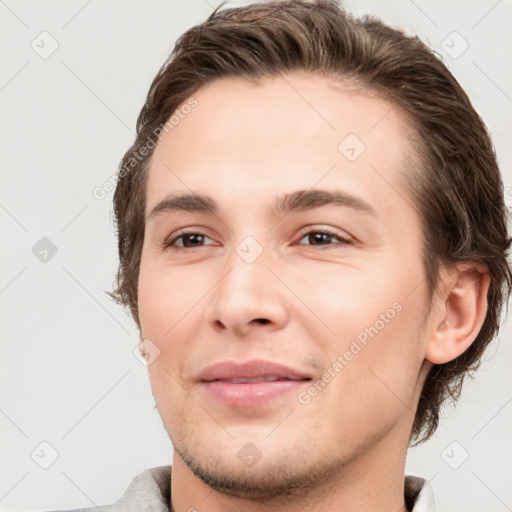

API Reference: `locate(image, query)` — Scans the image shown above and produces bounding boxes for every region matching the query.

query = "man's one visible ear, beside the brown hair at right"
[425,263,490,364]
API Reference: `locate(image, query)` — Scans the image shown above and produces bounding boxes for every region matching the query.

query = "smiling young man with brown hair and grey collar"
[46,0,512,512]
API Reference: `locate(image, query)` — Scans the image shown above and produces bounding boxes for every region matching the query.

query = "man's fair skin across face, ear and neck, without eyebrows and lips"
[139,73,488,512]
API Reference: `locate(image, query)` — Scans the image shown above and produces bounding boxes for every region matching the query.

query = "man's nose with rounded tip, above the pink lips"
[206,243,289,337]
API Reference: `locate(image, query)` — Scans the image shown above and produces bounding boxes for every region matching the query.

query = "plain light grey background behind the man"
[0,0,512,512]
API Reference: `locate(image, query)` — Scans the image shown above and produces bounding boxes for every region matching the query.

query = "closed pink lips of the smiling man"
[197,359,311,408]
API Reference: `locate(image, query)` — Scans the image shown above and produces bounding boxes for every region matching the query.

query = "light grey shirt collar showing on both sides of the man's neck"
[39,466,436,512]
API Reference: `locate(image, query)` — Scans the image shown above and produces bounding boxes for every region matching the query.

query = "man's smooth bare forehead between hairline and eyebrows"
[146,73,418,216]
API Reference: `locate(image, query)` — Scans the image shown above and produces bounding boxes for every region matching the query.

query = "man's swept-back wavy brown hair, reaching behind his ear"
[110,0,512,444]
